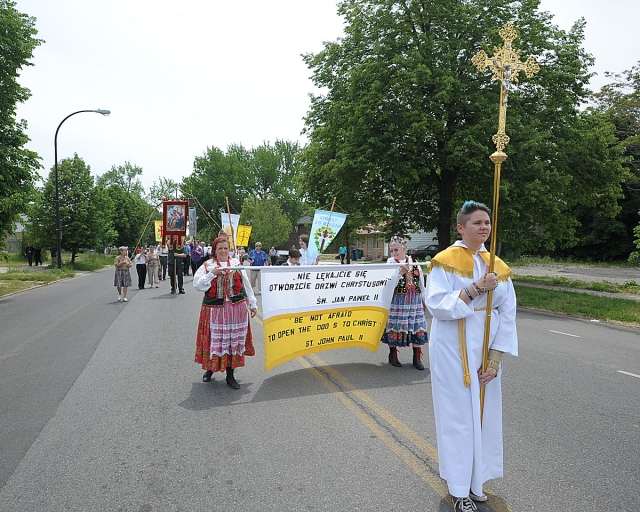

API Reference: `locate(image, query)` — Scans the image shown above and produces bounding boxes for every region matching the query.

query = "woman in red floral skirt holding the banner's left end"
[193,237,258,389]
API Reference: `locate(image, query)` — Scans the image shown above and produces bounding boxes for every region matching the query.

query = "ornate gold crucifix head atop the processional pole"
[471,23,540,153]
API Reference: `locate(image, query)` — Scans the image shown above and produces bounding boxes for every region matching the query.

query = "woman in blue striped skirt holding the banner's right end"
[382,236,428,370]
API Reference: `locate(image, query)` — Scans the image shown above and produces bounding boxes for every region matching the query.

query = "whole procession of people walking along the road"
[114,201,518,512]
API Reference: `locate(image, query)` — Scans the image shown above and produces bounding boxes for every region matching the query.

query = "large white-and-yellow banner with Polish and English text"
[260,265,398,371]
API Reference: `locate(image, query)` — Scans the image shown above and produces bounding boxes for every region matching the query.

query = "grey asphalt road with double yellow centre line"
[0,270,640,512]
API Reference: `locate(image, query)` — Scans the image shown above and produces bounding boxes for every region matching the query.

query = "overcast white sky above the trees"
[16,0,640,193]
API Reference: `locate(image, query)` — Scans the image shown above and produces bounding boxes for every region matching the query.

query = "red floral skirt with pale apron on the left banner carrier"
[194,300,256,373]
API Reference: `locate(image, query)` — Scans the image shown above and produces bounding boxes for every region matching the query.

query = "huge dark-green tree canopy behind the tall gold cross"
[304,0,626,255]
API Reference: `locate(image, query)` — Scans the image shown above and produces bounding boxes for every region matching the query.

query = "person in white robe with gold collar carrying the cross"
[427,201,518,512]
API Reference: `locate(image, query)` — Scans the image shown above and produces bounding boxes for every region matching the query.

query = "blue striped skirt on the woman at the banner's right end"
[382,289,429,347]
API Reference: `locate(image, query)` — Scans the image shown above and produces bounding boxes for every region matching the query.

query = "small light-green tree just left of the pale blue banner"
[240,196,293,247]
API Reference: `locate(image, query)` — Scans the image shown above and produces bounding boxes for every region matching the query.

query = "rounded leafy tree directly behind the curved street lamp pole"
[30,154,115,263]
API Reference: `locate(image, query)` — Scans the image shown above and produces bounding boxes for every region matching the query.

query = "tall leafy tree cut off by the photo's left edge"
[0,0,43,243]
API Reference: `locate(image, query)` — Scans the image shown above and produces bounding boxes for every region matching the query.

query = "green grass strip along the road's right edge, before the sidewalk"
[514,284,640,327]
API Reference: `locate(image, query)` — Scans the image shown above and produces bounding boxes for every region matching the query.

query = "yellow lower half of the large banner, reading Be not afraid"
[264,306,389,371]
